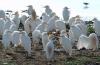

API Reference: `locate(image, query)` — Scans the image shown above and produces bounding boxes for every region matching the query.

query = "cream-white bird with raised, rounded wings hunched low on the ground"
[77,33,99,50]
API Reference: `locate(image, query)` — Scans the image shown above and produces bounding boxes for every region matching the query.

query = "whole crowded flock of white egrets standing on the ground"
[0,5,100,61]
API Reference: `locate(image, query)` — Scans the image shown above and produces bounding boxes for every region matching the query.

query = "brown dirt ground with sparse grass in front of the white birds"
[0,41,100,65]
